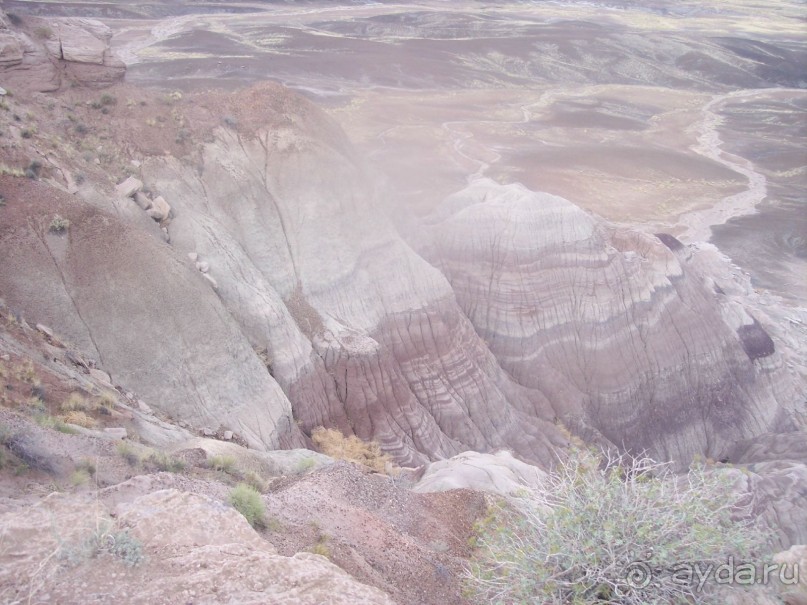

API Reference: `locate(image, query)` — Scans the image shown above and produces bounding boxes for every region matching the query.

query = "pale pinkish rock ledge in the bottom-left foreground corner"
[0,488,392,605]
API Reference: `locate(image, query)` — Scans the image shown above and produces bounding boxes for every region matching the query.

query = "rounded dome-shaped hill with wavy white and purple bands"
[426,180,796,461]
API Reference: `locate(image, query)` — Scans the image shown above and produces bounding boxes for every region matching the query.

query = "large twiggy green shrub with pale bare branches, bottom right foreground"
[466,451,768,605]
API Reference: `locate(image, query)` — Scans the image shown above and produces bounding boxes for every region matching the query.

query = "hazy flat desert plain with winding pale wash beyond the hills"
[42,2,807,300]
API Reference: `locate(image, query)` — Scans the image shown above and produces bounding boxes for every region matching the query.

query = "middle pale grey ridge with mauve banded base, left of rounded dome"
[143,85,564,463]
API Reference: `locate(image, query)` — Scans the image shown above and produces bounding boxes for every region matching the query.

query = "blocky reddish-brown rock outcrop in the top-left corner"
[0,11,126,92]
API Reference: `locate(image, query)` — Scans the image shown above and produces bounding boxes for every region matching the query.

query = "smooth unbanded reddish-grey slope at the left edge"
[0,176,303,449]
